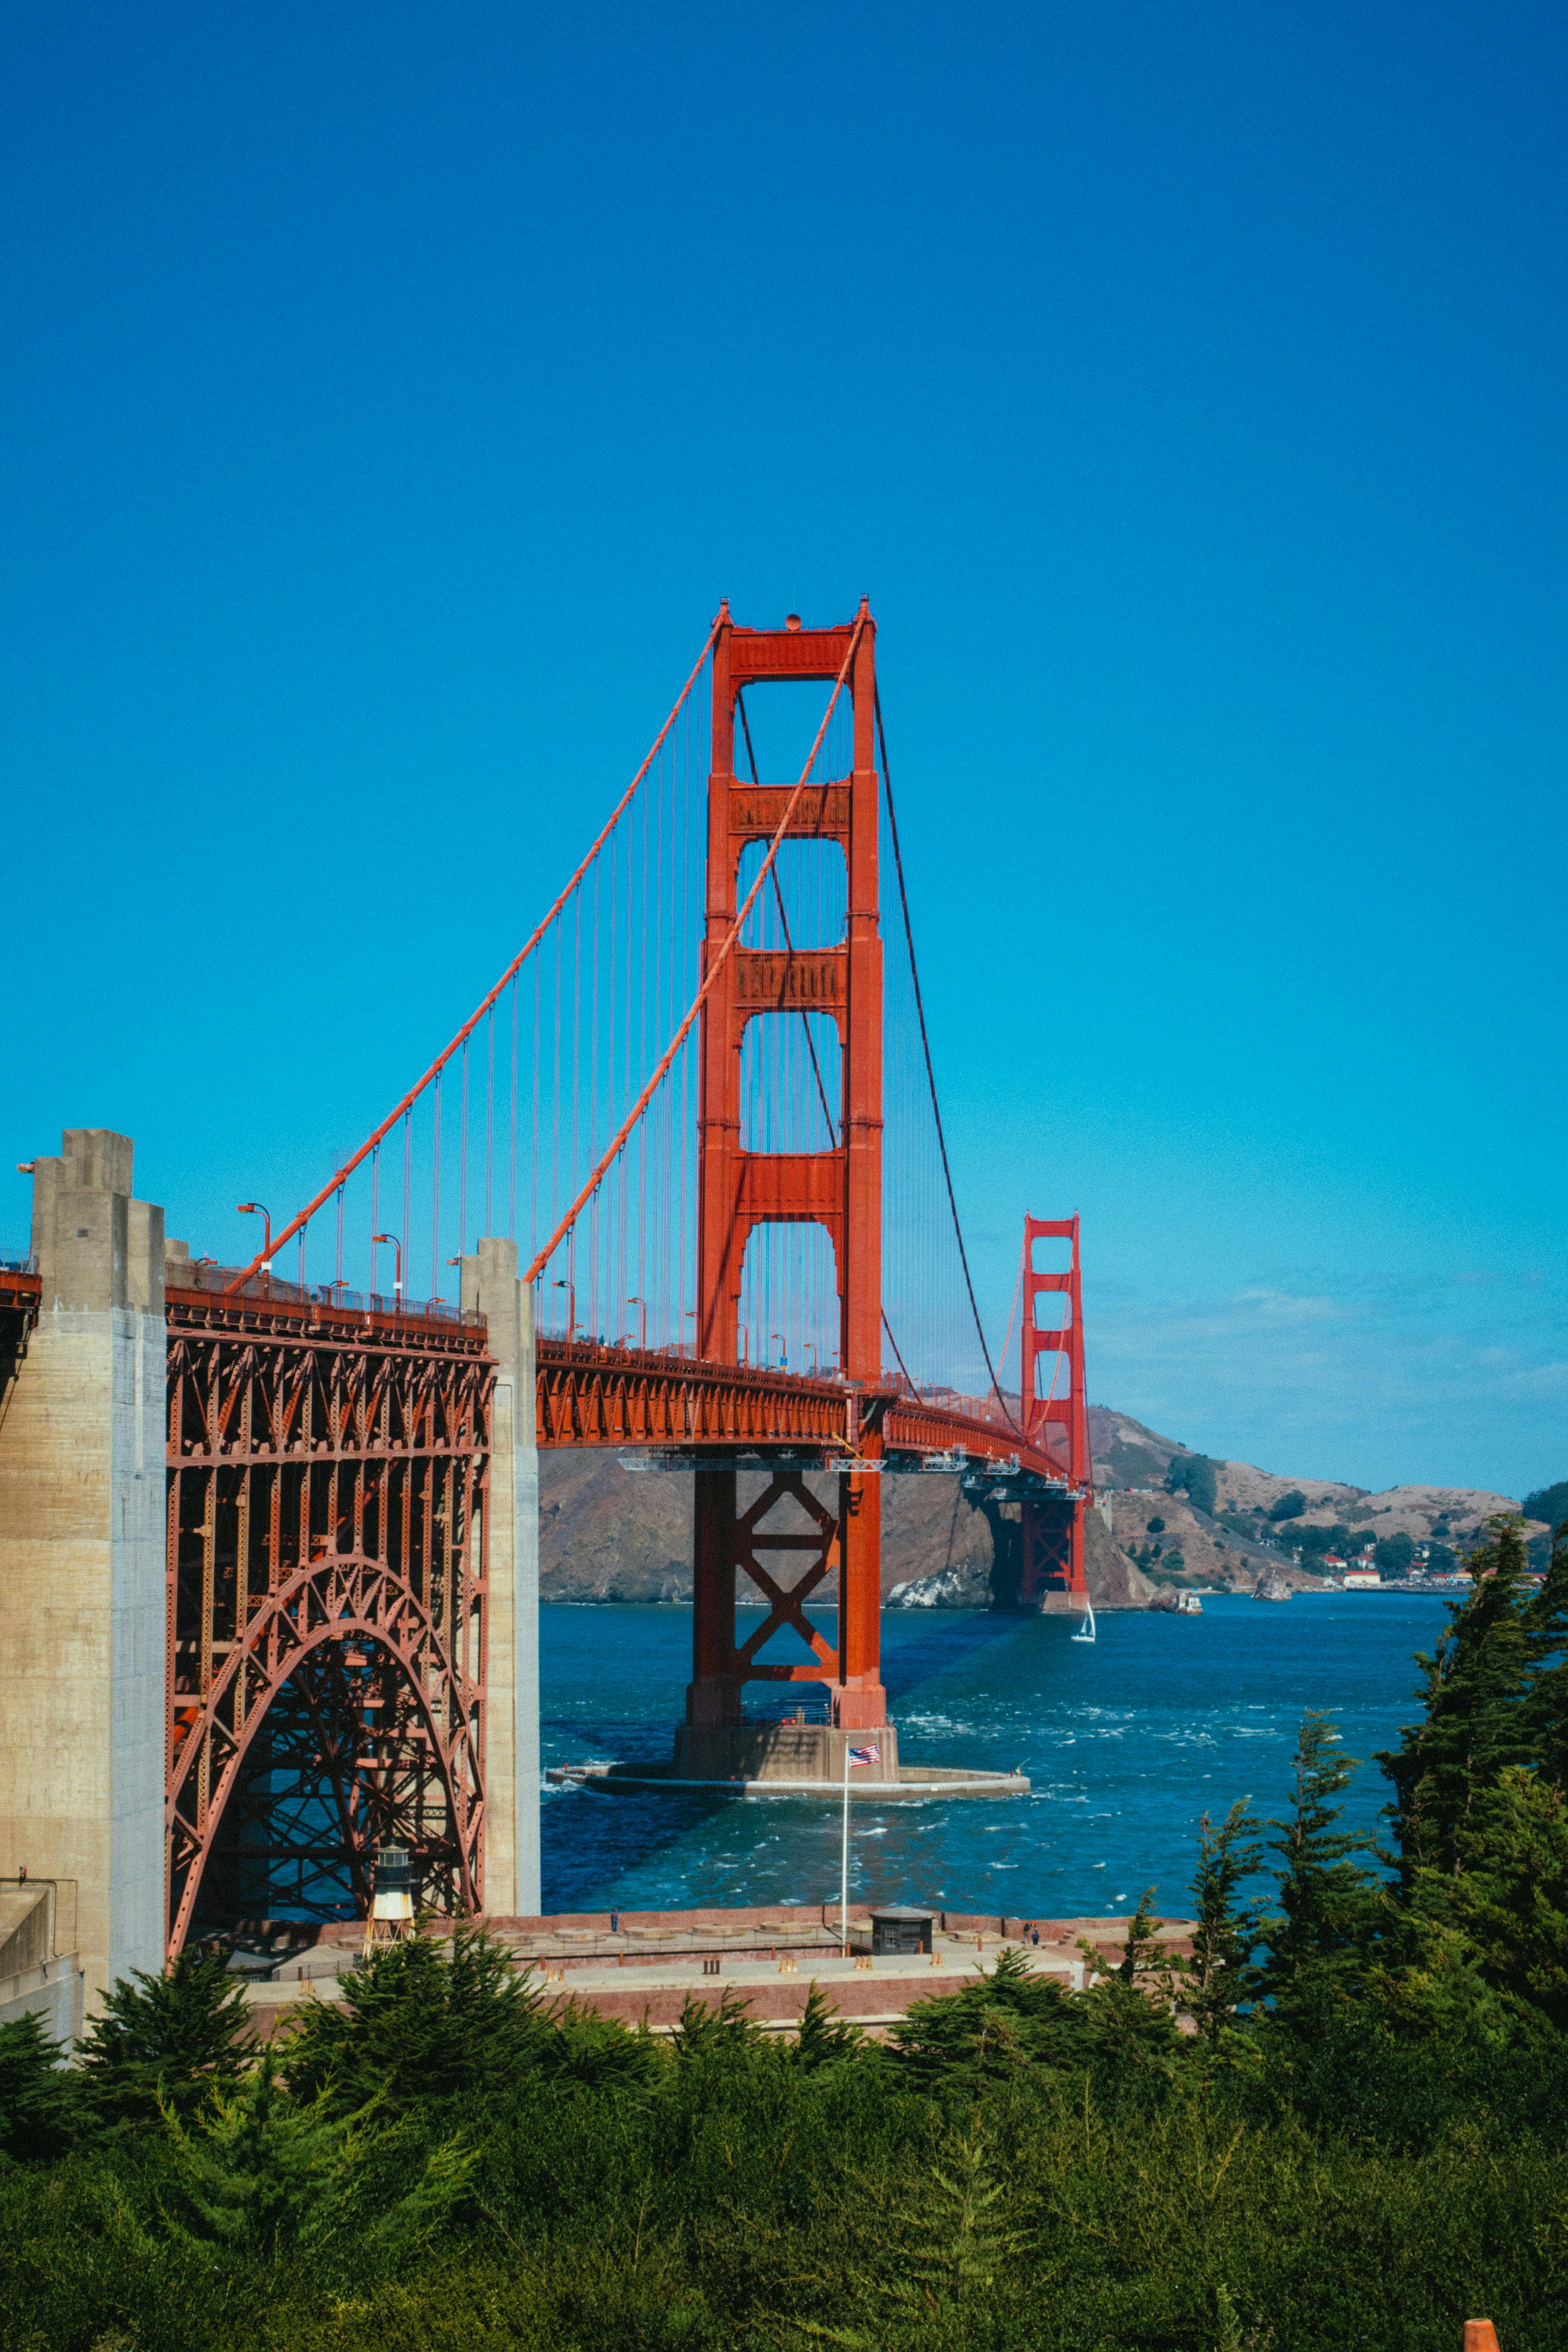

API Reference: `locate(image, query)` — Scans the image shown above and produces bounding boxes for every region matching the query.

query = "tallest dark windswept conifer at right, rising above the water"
[1378,1519,1535,1891]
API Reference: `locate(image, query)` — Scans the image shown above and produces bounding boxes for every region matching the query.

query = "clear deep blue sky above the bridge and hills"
[0,0,1568,1493]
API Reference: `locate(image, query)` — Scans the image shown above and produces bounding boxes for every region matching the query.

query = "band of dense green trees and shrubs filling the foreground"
[0,1522,1568,2352]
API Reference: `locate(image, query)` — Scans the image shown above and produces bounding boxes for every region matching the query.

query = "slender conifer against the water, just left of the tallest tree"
[1262,1712,1382,2023]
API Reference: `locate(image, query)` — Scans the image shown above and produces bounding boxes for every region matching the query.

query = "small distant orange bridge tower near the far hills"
[1018,1216,1093,1609]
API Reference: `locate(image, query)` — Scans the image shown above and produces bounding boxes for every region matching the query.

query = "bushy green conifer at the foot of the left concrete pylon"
[82,1950,249,2124]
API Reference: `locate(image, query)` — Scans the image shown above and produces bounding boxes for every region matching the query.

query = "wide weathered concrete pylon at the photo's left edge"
[0,1127,167,2013]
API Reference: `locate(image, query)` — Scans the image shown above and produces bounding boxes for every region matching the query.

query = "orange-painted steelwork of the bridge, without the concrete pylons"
[153,602,1091,1952]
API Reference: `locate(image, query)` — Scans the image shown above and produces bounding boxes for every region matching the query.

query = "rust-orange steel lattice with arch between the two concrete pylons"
[167,1279,496,1952]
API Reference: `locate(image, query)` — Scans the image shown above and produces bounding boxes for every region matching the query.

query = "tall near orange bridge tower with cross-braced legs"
[687,602,886,1729]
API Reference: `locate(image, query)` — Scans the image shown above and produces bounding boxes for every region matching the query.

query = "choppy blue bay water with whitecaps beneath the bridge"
[541,1592,1446,1919]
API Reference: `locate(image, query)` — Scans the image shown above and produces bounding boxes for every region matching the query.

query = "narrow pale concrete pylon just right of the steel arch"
[461,1240,541,1919]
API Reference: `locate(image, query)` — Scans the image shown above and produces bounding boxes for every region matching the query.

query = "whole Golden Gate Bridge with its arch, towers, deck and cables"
[0,602,1091,1950]
